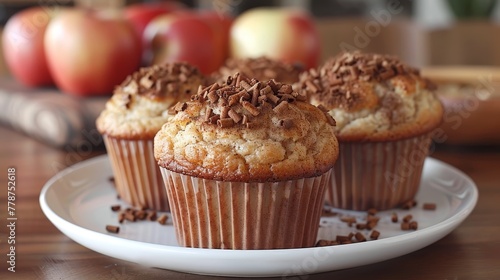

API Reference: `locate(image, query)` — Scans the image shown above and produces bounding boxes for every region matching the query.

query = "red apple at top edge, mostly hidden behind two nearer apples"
[123,1,187,48]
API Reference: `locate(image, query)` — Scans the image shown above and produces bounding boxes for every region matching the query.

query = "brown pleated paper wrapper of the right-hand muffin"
[325,135,431,211]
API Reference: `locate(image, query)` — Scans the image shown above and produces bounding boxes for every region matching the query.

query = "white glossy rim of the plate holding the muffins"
[39,154,479,277]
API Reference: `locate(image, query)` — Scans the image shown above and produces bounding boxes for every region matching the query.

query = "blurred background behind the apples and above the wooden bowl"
[0,0,500,73]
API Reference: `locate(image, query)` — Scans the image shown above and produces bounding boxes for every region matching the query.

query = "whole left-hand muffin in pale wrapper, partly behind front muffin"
[96,63,204,211]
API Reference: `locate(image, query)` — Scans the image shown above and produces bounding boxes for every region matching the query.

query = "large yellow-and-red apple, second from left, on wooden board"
[44,9,141,95]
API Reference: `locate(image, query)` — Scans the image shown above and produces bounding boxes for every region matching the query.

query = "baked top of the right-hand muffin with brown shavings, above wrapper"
[294,52,443,142]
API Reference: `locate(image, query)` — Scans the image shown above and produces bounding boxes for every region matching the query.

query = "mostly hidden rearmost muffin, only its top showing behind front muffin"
[211,56,304,84]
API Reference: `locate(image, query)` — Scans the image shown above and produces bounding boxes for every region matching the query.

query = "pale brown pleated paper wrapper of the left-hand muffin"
[103,135,169,211]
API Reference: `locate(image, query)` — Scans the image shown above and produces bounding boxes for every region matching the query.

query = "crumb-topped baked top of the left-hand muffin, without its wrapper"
[96,63,205,140]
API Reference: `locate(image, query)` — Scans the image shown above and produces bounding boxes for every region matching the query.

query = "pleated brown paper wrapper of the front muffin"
[160,168,331,249]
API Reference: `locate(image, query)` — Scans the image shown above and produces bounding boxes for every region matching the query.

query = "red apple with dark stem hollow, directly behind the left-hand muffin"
[144,12,223,74]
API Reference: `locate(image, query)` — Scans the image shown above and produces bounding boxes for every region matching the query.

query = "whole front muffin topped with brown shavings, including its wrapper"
[154,74,338,249]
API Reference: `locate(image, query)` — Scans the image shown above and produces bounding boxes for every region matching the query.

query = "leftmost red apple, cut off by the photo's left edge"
[2,7,53,86]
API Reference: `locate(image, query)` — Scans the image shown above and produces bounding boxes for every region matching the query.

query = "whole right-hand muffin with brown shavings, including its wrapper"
[297,52,443,210]
